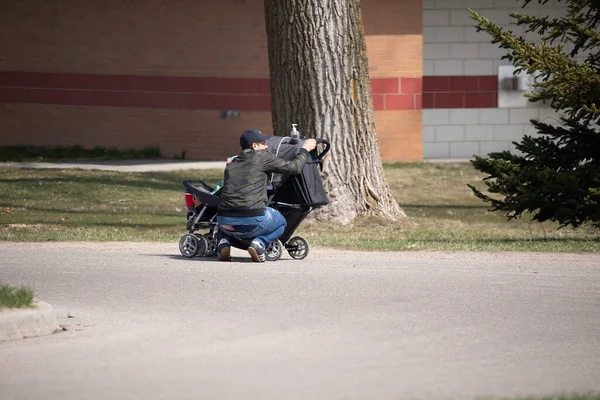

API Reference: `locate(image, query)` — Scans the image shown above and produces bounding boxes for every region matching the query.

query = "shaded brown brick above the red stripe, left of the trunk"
[0,0,269,78]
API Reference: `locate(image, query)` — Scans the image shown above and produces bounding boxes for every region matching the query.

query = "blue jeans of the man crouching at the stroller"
[217,207,287,248]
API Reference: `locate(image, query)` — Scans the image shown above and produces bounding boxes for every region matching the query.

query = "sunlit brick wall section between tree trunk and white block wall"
[361,0,423,162]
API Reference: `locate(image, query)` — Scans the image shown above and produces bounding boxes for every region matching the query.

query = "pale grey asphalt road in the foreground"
[0,243,600,400]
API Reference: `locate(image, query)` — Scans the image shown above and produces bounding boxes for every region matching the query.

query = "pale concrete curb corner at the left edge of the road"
[0,301,59,342]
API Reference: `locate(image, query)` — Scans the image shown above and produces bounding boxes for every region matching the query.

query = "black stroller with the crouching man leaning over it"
[179,136,330,261]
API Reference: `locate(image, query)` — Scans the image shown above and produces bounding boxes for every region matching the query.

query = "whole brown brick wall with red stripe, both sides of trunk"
[0,0,422,161]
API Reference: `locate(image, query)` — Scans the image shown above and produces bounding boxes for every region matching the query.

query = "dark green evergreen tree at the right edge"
[469,0,600,228]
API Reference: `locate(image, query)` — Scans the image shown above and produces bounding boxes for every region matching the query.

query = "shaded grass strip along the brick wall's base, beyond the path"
[0,146,160,162]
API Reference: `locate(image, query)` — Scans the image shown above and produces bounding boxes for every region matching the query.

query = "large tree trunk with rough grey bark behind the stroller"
[265,0,406,223]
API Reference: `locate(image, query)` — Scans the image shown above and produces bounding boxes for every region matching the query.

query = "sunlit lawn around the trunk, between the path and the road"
[0,163,600,252]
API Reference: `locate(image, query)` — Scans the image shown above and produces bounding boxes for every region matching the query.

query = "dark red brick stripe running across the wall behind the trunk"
[0,71,497,111]
